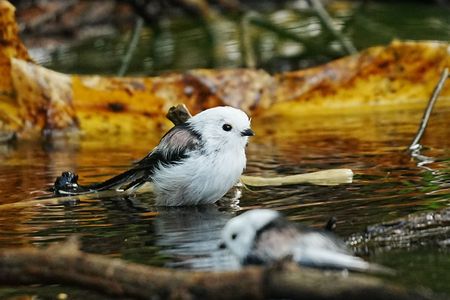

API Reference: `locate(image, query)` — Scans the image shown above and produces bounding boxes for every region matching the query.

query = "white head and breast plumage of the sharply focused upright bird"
[152,107,253,206]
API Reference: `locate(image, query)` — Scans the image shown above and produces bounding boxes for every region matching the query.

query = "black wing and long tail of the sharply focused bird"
[54,123,202,194]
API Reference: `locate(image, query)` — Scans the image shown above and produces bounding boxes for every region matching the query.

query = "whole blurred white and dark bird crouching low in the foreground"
[220,209,392,273]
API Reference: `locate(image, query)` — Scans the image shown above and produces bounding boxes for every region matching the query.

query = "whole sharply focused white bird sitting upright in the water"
[54,106,254,206]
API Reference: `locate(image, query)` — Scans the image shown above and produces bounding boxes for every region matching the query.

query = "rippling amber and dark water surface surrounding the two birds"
[0,107,450,298]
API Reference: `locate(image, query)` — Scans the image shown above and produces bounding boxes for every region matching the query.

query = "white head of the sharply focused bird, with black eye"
[188,106,254,148]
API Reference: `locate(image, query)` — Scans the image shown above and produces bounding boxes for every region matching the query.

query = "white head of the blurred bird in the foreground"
[219,209,280,261]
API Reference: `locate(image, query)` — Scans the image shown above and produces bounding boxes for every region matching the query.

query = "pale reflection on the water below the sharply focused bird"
[154,189,241,270]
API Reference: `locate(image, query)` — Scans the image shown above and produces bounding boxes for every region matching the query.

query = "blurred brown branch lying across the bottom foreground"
[0,239,433,300]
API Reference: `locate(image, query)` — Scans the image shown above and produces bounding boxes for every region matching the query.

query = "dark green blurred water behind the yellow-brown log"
[32,1,450,75]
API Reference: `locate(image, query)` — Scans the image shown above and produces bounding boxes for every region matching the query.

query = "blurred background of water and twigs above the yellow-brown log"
[12,0,450,75]
